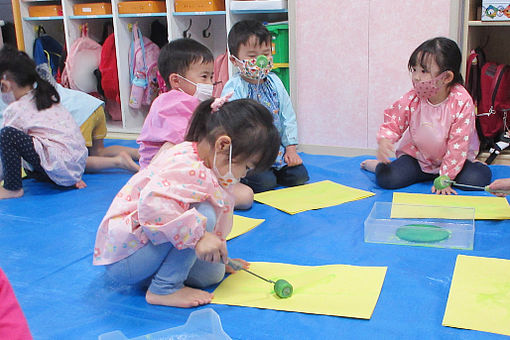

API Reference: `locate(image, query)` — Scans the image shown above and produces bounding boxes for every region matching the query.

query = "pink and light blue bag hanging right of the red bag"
[129,24,159,109]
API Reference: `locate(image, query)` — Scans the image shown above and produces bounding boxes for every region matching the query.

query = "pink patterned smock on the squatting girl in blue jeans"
[94,142,234,265]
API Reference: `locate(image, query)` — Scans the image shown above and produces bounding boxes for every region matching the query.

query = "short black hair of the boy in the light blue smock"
[228,20,271,57]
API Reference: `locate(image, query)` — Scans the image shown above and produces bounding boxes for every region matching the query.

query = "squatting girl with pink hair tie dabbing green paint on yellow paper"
[94,97,279,307]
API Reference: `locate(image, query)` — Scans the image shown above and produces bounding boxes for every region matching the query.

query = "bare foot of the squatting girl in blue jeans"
[145,286,214,308]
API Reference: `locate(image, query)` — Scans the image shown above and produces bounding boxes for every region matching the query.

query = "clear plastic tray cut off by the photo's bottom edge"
[99,308,231,340]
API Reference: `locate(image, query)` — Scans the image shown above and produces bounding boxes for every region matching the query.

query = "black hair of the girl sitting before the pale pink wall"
[407,37,464,85]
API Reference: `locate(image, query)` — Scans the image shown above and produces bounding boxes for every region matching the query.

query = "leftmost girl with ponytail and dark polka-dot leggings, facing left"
[0,45,87,199]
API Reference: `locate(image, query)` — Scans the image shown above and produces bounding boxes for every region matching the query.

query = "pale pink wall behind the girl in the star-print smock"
[295,0,458,149]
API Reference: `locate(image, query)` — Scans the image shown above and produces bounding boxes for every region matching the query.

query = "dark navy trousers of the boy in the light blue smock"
[241,164,310,193]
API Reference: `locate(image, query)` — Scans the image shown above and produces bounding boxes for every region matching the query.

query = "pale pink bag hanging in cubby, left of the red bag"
[61,24,101,93]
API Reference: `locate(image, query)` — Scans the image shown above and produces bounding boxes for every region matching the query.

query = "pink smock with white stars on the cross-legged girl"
[377,84,480,179]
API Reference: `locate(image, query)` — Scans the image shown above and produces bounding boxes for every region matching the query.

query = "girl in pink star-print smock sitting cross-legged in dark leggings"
[361,37,492,194]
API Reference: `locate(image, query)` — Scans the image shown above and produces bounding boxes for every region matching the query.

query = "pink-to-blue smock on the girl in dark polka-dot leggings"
[3,92,88,186]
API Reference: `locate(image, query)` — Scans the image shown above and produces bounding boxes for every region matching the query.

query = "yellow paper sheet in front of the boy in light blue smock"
[255,181,375,215]
